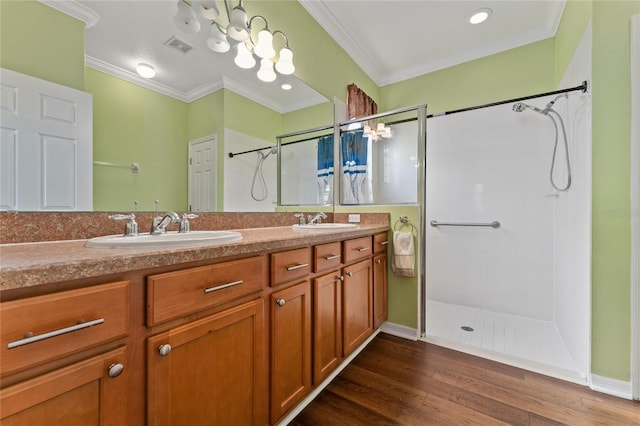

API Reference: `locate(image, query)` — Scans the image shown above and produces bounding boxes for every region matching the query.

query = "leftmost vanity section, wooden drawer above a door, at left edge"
[0,281,129,426]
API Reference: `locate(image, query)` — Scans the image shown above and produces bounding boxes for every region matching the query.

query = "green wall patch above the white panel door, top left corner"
[0,0,84,90]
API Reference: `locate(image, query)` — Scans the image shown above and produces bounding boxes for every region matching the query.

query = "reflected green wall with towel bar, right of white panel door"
[85,68,188,211]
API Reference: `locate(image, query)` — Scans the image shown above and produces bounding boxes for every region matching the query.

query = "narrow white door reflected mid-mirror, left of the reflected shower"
[189,135,218,212]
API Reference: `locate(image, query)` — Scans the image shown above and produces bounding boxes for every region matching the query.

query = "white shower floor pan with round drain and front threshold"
[423,301,587,385]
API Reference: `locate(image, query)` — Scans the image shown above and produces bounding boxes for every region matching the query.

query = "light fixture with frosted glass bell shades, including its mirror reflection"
[173,0,296,82]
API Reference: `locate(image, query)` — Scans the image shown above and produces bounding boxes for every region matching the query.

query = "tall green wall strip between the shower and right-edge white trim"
[591,1,640,381]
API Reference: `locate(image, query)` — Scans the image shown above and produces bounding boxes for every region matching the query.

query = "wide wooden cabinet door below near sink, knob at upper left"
[147,299,267,426]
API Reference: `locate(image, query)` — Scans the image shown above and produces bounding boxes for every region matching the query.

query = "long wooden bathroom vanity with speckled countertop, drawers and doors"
[0,224,389,426]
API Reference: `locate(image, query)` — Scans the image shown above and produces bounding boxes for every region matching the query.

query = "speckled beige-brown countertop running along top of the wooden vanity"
[0,224,389,291]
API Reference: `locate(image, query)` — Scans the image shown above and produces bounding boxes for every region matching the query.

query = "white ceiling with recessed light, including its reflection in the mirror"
[41,0,565,107]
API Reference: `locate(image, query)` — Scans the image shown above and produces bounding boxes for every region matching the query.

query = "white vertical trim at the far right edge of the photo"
[630,15,640,399]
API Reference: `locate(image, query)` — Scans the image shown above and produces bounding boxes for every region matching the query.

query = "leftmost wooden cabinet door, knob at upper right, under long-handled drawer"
[0,347,127,426]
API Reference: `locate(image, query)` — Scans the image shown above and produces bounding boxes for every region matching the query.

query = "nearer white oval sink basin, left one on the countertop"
[87,231,242,248]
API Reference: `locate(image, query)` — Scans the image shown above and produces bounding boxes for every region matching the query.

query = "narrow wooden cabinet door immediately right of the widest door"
[271,280,311,423]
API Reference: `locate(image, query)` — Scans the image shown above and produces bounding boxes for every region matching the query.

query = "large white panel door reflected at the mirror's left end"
[0,68,93,211]
